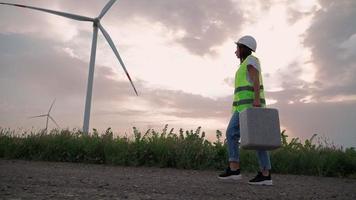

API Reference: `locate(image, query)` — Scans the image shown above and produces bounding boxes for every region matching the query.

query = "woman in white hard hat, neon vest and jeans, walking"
[219,36,272,185]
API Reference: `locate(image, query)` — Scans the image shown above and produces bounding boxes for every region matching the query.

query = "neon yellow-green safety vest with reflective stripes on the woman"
[232,55,266,112]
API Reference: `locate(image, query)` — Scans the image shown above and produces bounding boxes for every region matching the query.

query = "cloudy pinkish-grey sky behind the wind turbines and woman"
[0,0,356,147]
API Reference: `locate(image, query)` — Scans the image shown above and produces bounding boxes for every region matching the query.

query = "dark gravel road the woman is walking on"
[0,159,356,200]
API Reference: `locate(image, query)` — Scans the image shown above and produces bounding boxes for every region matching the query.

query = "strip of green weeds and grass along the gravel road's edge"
[0,125,356,178]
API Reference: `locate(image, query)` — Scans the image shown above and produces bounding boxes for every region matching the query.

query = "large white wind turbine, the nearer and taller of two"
[0,0,138,133]
